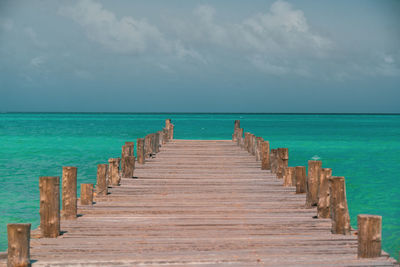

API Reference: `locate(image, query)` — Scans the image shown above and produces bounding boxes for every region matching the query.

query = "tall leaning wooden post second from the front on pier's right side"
[330,177,350,235]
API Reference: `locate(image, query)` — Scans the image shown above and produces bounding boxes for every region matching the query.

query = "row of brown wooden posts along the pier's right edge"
[232,120,382,258]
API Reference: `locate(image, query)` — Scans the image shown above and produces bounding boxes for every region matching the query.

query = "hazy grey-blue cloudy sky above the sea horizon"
[0,0,400,113]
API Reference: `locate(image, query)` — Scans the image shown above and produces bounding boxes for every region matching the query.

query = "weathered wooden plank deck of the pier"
[3,140,396,266]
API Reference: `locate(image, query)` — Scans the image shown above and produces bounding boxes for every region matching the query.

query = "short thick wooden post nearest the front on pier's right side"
[357,214,382,258]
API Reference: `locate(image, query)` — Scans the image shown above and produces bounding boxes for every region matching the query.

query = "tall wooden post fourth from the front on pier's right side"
[306,160,322,208]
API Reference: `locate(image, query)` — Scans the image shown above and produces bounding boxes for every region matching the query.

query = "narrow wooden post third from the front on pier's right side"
[317,168,332,218]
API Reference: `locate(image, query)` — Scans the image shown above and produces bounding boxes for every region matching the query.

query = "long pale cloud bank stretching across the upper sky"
[57,0,400,80]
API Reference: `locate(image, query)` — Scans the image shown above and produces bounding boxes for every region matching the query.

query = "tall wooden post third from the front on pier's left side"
[61,167,77,220]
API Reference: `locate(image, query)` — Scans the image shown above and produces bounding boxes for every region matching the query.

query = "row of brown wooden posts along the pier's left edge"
[7,119,174,267]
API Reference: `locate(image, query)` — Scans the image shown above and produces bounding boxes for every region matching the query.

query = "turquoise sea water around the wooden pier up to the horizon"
[0,113,400,258]
